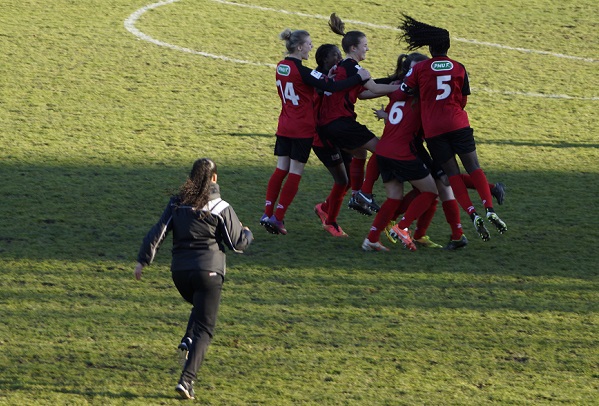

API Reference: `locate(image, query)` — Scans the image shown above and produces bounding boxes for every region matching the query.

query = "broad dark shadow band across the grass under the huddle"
[0,160,599,279]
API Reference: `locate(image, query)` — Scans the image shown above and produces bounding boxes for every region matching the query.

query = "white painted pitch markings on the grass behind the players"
[124,0,599,100]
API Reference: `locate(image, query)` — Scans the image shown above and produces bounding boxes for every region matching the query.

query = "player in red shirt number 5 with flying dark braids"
[399,15,507,241]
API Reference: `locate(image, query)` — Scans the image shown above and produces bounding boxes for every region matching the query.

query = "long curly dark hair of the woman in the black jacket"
[177,158,217,210]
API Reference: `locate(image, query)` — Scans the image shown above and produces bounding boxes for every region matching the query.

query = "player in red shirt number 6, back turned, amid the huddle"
[362,53,438,251]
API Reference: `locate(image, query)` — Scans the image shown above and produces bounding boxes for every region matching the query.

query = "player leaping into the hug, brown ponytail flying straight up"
[318,13,398,219]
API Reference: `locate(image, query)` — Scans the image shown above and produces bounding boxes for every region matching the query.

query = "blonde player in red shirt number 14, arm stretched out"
[260,28,370,235]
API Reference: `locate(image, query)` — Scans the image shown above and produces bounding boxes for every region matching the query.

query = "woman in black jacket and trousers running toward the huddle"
[134,158,253,399]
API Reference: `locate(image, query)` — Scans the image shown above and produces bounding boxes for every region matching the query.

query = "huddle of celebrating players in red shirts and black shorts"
[260,14,507,251]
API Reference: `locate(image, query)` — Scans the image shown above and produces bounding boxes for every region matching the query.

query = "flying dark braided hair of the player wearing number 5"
[397,14,450,56]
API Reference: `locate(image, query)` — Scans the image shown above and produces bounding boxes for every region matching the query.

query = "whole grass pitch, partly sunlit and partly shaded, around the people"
[0,0,599,405]
